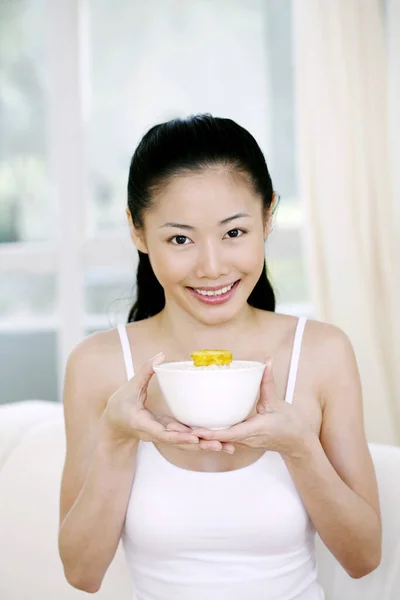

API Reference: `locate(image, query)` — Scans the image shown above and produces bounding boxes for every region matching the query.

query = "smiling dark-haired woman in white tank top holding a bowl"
[59,115,381,600]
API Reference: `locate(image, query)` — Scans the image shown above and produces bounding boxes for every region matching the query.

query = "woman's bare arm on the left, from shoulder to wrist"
[59,334,137,592]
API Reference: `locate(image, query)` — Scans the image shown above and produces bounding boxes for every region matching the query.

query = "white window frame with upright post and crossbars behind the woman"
[0,0,314,398]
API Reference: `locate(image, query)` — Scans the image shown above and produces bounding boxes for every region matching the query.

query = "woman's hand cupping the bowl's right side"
[191,359,316,456]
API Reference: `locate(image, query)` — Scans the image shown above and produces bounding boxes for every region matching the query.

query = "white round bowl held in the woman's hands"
[154,360,265,429]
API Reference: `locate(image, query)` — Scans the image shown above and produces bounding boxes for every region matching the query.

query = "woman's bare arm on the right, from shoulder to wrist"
[285,326,382,578]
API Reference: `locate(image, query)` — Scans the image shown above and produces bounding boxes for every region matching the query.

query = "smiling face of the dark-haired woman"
[134,168,266,325]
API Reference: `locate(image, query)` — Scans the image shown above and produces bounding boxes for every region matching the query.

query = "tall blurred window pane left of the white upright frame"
[0,0,54,243]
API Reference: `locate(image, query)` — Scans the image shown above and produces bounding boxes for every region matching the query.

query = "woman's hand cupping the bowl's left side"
[102,352,234,453]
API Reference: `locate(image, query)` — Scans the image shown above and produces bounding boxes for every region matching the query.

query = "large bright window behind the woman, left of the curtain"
[0,0,309,401]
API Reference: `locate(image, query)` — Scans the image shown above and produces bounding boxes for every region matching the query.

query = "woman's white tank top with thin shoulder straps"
[118,318,324,600]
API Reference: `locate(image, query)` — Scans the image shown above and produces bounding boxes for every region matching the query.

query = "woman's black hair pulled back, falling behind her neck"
[128,114,275,323]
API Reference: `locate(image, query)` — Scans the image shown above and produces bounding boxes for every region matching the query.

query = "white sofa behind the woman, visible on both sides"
[0,400,400,600]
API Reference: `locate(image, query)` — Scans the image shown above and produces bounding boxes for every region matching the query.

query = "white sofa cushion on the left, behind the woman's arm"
[0,403,132,600]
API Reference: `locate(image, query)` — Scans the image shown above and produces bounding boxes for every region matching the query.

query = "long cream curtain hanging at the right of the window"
[293,0,400,444]
